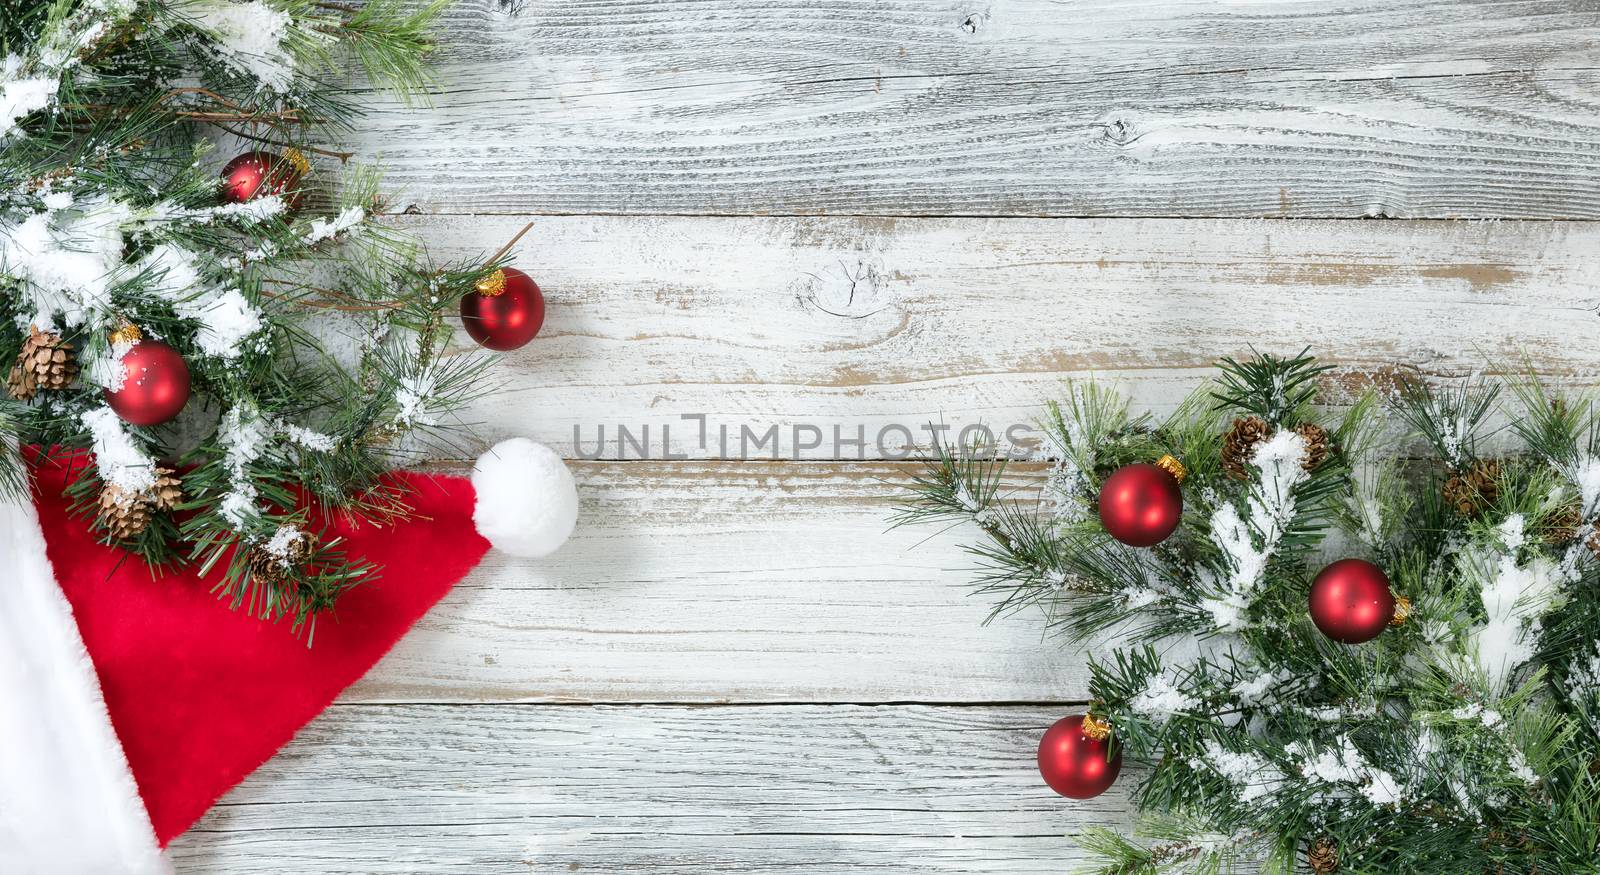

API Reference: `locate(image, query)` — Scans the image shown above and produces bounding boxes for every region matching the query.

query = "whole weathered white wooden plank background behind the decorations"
[173,0,1600,873]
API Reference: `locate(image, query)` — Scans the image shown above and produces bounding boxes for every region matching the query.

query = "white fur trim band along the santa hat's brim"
[0,483,171,875]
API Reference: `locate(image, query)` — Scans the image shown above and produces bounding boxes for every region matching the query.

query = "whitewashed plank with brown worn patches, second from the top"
[393,218,1600,459]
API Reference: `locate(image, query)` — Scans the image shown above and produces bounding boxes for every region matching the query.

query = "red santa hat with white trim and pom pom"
[0,438,578,875]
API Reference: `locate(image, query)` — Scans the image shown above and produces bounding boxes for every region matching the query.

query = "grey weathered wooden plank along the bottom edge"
[171,705,1134,875]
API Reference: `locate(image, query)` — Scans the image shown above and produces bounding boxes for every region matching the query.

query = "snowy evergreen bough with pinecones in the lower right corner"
[898,354,1600,875]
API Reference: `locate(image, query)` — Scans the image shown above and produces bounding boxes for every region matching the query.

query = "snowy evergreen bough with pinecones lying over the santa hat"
[0,0,498,639]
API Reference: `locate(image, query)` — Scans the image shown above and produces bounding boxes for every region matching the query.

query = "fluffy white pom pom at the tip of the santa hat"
[472,438,578,558]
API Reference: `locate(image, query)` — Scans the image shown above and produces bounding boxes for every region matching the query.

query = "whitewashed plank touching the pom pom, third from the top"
[344,462,1086,702]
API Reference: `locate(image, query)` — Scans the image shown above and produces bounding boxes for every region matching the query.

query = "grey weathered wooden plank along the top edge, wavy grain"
[355,0,1600,218]
